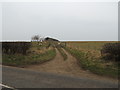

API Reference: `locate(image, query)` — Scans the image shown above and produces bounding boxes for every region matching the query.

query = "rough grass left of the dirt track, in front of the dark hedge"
[2,43,56,67]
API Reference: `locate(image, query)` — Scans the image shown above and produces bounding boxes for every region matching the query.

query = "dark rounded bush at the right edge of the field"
[101,43,120,61]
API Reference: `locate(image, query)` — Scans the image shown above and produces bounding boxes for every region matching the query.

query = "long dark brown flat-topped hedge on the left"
[2,42,31,54]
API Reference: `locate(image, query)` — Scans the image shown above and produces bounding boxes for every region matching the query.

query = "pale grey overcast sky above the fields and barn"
[0,2,118,41]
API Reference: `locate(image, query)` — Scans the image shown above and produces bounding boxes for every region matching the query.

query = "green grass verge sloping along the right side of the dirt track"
[65,47,120,78]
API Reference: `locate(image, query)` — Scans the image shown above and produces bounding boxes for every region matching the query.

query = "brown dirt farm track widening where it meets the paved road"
[25,49,118,82]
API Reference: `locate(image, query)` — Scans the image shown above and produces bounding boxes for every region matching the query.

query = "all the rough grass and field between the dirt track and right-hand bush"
[65,42,120,78]
